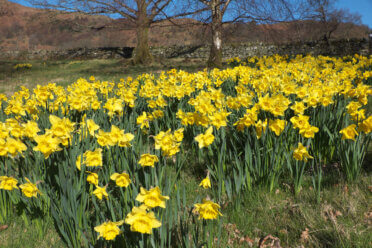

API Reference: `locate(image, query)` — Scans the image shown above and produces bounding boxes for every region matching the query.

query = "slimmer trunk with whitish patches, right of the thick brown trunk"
[208,0,222,68]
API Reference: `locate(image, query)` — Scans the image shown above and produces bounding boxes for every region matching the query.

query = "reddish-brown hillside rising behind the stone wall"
[0,0,369,51]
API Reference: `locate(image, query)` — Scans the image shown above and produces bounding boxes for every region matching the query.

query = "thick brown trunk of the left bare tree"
[133,4,153,65]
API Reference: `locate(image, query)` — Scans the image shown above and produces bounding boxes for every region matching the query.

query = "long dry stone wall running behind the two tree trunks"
[0,39,371,60]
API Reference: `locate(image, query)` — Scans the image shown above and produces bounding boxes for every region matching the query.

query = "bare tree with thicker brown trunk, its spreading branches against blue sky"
[29,0,189,64]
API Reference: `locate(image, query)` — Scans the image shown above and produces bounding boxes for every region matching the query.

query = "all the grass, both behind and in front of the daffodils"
[0,60,372,248]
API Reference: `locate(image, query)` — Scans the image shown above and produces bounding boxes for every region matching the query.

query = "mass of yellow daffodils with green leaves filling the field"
[0,55,372,247]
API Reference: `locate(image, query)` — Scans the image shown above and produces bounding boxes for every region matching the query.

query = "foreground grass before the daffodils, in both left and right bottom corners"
[0,172,372,248]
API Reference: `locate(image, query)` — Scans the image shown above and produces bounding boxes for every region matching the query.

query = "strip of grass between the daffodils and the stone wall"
[0,59,204,95]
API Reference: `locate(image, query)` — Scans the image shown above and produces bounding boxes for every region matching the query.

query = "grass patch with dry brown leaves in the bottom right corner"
[230,176,372,247]
